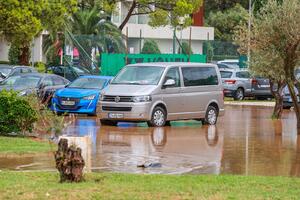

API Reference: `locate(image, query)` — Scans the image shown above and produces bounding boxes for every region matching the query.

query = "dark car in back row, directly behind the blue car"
[47,66,92,81]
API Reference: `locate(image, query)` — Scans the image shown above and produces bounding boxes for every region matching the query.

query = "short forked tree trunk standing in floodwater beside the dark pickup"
[270,80,285,119]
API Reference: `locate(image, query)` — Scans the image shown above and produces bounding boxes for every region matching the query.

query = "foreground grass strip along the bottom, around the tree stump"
[0,171,300,200]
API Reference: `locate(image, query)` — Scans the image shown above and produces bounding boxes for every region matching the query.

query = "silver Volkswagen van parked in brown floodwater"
[98,63,224,127]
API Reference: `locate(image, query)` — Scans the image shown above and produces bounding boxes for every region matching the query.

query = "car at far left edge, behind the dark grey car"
[0,65,37,81]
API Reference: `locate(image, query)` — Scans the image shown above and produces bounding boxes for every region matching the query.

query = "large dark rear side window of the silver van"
[182,67,218,86]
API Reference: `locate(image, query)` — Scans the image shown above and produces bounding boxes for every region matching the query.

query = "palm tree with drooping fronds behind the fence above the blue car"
[67,7,125,67]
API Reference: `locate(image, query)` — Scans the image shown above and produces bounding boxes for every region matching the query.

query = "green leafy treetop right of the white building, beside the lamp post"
[206,4,248,41]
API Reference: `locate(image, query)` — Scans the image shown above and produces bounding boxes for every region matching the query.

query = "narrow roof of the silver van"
[127,62,216,67]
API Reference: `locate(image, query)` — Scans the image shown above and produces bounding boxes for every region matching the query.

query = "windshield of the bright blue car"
[68,77,106,89]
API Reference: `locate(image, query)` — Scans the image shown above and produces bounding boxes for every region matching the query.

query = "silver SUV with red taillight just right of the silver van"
[220,69,252,100]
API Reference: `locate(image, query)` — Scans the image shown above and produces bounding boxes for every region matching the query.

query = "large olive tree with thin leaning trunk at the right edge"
[238,0,300,130]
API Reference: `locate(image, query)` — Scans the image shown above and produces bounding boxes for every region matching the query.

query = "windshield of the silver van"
[112,66,165,85]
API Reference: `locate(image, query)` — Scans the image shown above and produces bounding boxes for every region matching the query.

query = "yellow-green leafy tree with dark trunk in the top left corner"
[0,0,76,65]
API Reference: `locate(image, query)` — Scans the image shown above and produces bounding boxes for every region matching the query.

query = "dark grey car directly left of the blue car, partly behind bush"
[0,73,70,103]
